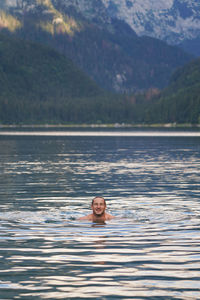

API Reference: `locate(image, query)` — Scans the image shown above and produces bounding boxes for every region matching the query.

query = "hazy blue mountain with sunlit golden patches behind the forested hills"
[0,0,194,93]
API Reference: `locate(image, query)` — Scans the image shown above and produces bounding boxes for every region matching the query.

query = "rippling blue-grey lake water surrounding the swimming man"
[0,128,200,300]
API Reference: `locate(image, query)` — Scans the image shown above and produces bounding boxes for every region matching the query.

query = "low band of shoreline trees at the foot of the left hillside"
[0,95,142,124]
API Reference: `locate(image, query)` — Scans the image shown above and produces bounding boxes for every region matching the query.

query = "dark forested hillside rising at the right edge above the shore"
[145,58,200,124]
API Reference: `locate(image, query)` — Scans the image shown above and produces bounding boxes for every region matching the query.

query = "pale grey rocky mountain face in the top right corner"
[102,0,200,56]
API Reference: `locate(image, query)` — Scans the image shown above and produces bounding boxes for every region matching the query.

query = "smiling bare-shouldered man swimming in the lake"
[79,197,115,223]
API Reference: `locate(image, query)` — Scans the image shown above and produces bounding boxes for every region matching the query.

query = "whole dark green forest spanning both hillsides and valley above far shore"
[0,34,200,124]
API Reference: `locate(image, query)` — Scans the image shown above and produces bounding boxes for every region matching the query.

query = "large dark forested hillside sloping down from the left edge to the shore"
[0,34,141,125]
